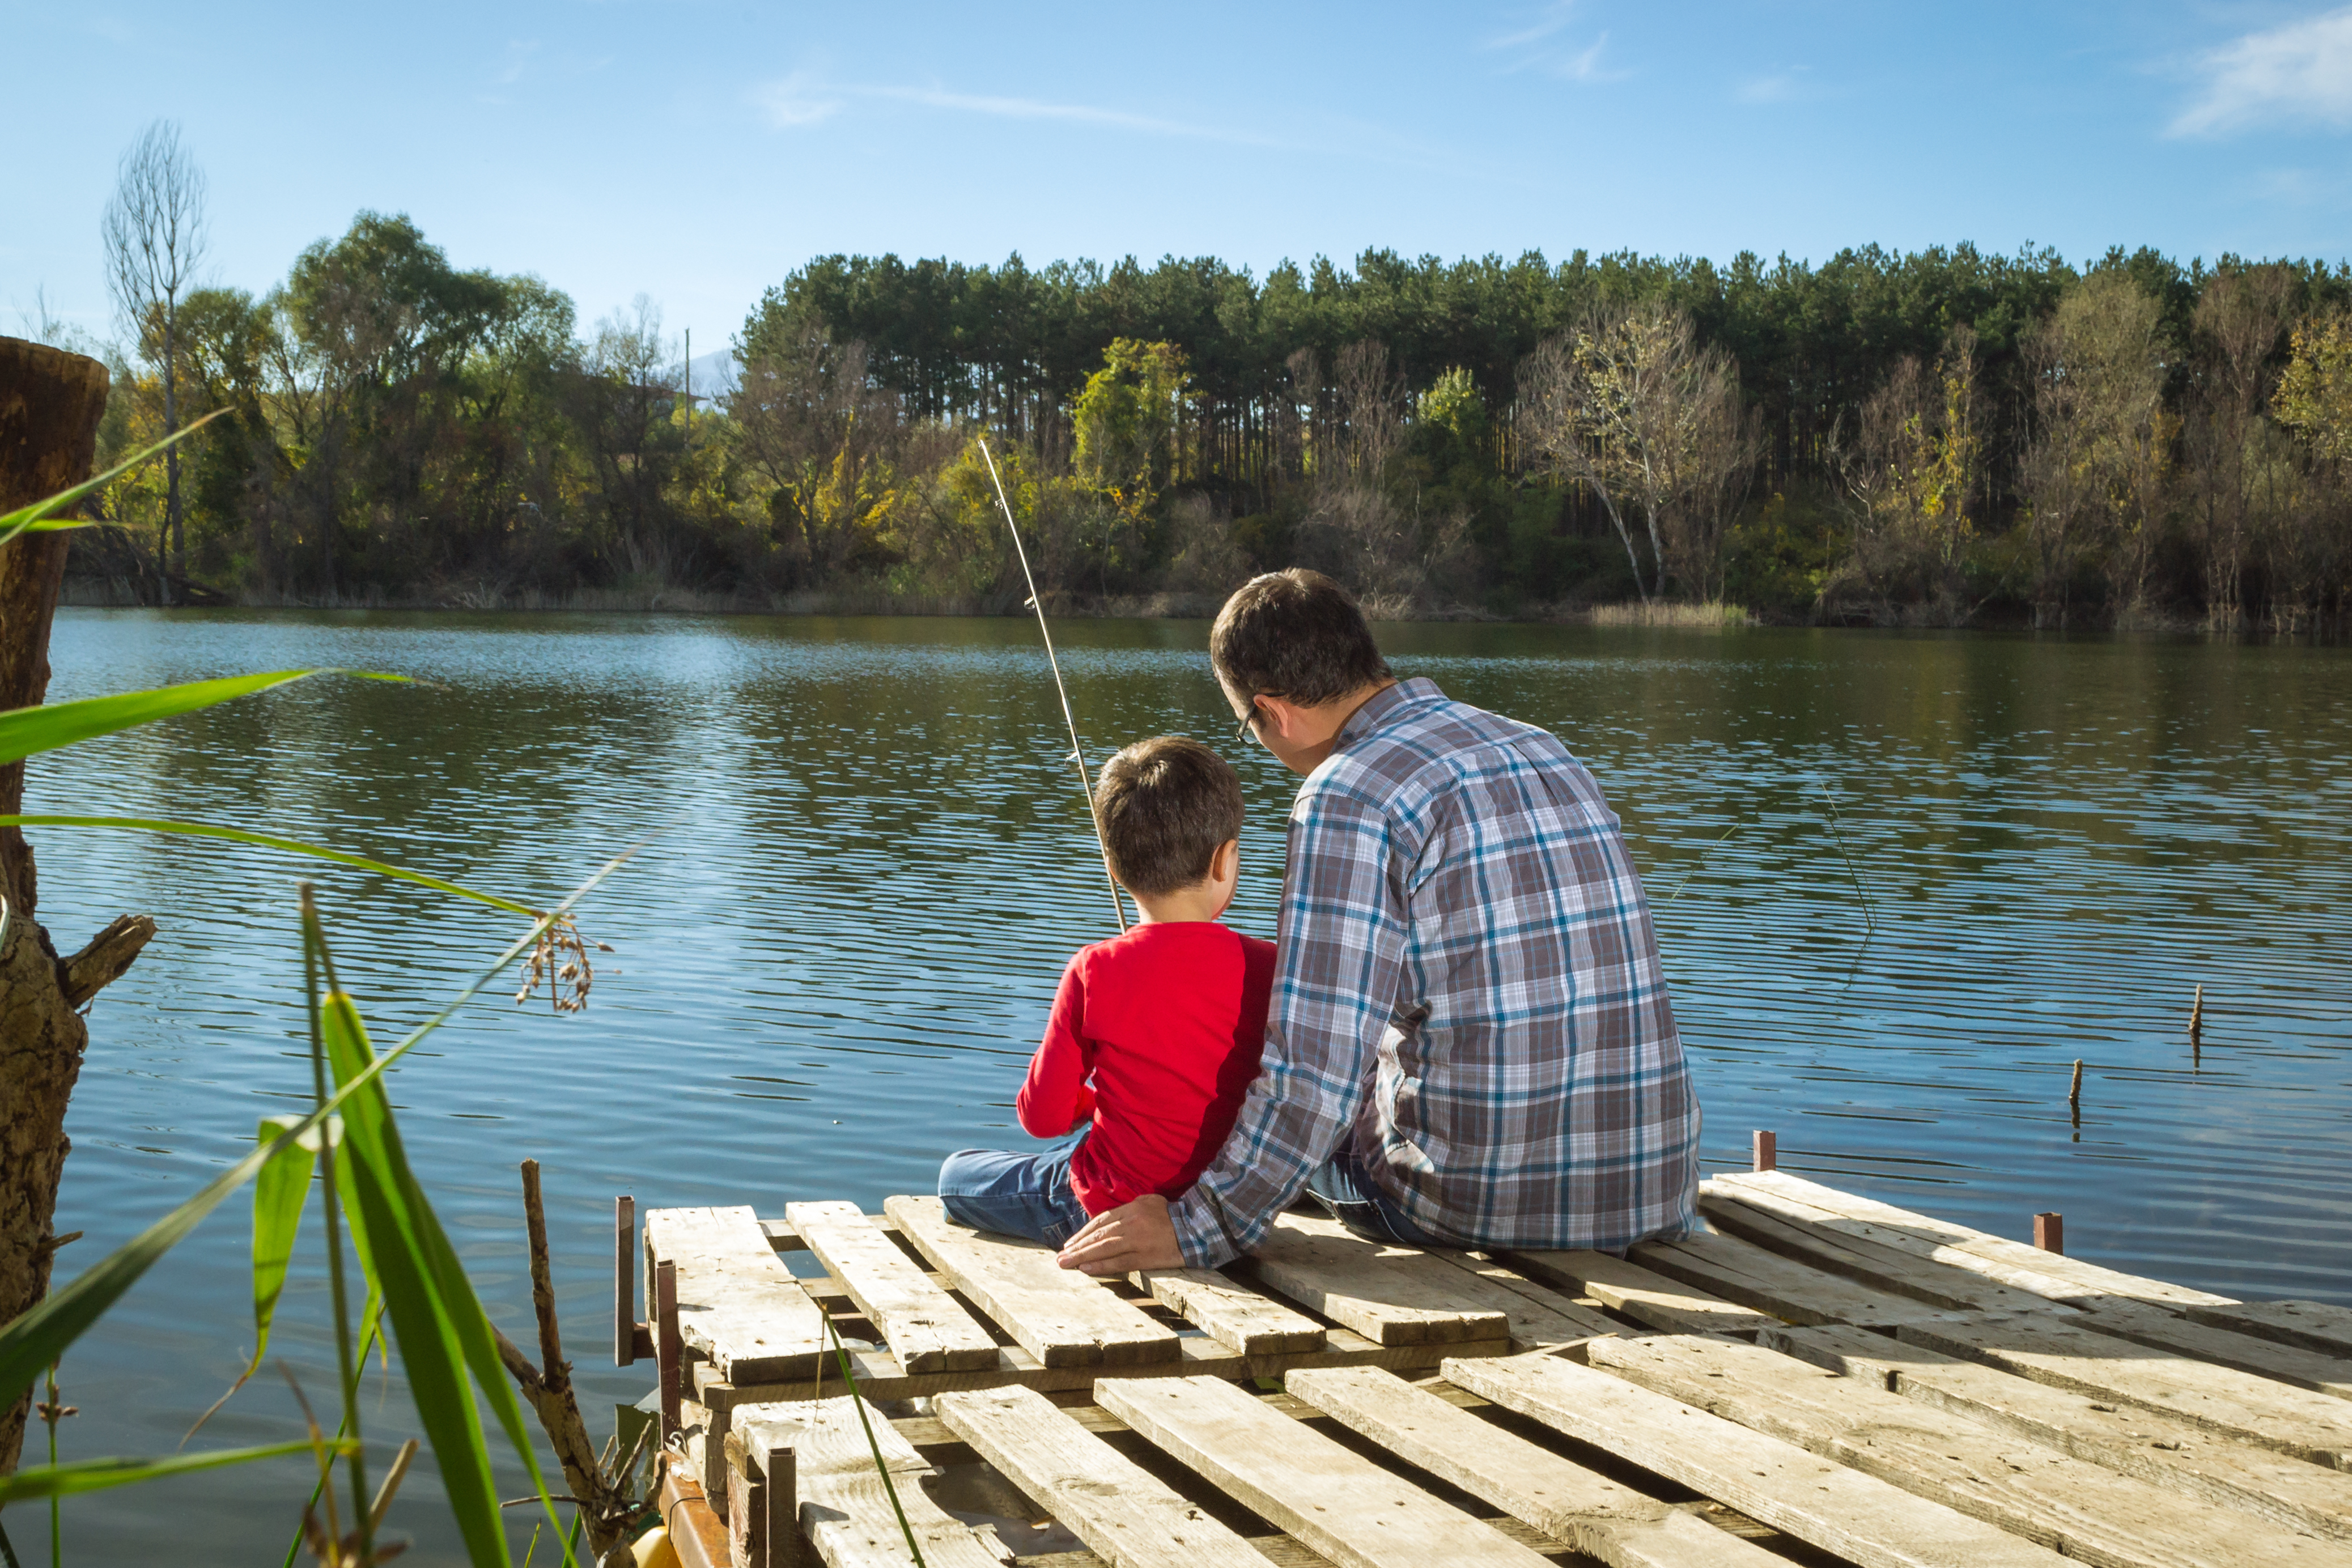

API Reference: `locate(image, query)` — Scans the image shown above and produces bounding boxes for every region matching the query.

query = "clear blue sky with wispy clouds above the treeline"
[0,0,2352,352]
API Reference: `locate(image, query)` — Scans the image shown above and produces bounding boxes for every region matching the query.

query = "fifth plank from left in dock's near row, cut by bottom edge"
[1444,1340,2063,1568]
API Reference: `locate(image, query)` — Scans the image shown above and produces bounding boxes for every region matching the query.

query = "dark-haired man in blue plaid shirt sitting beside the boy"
[1061,569,1698,1274]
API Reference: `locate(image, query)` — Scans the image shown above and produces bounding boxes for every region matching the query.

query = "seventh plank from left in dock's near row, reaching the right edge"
[1764,1328,2352,1540]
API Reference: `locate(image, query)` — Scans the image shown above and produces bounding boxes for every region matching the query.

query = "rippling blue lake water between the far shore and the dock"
[23,611,2352,1563]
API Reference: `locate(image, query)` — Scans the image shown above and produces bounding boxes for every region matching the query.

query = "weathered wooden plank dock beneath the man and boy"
[616,1166,2352,1568]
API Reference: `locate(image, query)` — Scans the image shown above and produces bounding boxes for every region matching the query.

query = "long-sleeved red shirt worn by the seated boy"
[1014,919,1275,1213]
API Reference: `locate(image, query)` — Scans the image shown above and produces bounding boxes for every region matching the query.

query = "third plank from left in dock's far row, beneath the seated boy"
[882,1197,1178,1366]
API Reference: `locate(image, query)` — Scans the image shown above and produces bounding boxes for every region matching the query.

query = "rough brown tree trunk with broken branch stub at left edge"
[0,338,155,1474]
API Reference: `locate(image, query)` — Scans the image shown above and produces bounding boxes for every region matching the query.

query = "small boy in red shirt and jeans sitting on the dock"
[939,736,1275,1248]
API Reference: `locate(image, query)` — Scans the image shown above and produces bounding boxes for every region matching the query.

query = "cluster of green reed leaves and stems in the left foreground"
[0,426,632,1568]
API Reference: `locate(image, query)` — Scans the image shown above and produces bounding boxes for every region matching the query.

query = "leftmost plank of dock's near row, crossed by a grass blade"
[734,1399,1012,1568]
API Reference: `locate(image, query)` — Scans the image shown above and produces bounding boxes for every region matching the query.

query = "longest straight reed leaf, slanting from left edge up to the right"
[0,849,638,1404]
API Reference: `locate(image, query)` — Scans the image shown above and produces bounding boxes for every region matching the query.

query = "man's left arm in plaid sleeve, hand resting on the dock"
[1110,785,1404,1272]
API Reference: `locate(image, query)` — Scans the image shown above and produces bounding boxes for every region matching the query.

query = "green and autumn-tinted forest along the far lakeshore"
[68,214,2352,632]
